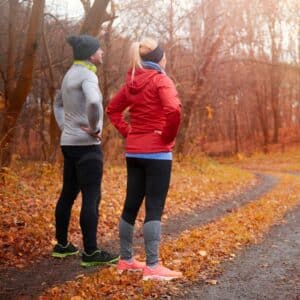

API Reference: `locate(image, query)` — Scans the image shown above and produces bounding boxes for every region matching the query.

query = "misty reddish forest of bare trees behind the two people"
[0,0,300,168]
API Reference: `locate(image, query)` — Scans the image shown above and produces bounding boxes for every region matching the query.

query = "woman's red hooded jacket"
[107,69,181,153]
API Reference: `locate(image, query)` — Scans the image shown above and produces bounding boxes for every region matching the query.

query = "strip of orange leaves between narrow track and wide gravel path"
[41,176,300,299]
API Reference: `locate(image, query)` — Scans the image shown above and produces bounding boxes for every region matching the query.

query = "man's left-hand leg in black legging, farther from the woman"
[55,150,79,246]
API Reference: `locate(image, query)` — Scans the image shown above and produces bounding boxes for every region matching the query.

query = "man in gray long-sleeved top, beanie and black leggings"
[52,35,118,267]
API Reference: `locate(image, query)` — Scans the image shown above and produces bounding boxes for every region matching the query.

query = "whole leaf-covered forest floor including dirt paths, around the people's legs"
[0,152,300,300]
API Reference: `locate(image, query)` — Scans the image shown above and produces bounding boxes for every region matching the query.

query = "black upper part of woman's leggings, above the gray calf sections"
[122,158,172,225]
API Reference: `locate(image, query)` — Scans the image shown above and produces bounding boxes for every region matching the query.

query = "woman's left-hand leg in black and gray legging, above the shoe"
[119,158,145,260]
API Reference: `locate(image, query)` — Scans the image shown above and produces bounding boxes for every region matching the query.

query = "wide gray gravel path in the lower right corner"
[184,203,300,300]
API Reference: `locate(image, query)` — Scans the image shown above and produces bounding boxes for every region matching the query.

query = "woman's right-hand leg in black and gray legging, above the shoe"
[144,160,172,266]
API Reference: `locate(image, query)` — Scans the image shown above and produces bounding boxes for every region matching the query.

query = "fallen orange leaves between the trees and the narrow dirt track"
[0,158,254,268]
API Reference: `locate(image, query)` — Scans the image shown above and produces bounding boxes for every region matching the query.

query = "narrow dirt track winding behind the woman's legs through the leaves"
[0,174,278,299]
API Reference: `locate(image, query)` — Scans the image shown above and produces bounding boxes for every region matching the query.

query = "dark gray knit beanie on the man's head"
[66,34,100,60]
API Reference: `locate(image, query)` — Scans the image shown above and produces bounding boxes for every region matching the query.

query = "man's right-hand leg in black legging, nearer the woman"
[76,147,103,254]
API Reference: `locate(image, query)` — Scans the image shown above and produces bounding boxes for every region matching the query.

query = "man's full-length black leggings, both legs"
[55,145,103,253]
